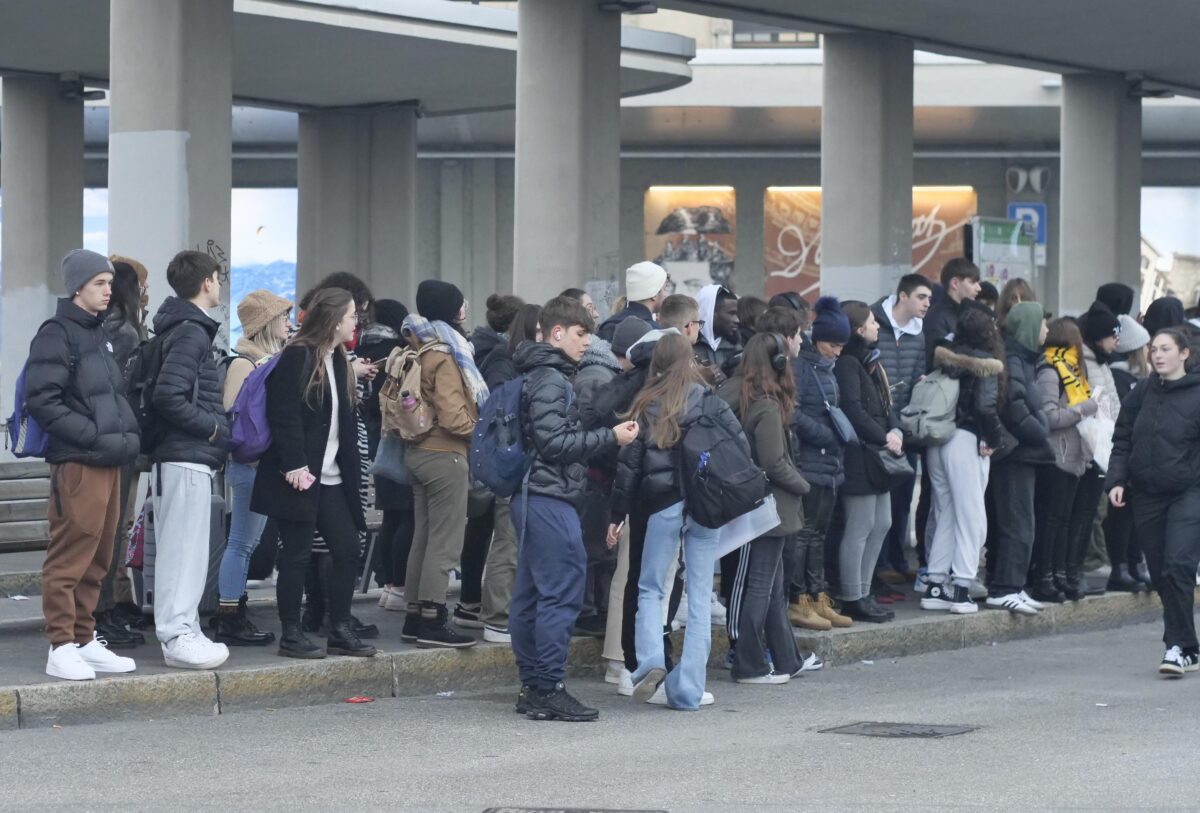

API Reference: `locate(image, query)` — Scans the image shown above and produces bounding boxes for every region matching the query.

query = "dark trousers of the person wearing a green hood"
[988,459,1038,596]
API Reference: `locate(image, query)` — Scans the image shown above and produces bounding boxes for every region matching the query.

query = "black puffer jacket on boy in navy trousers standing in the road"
[514,342,617,506]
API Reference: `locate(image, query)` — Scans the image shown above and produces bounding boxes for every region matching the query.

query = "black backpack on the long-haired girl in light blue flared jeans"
[679,393,768,528]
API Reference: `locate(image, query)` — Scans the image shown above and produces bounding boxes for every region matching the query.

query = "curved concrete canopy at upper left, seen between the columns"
[0,0,695,115]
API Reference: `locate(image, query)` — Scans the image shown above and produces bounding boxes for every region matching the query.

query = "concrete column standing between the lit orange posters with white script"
[821,34,912,302]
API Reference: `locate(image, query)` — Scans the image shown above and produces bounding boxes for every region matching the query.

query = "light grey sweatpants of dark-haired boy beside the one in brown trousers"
[150,463,212,644]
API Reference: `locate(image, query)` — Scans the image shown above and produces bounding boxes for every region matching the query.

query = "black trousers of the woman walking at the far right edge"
[1133,488,1200,650]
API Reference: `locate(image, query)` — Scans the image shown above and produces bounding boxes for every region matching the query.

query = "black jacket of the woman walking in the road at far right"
[1104,371,1200,494]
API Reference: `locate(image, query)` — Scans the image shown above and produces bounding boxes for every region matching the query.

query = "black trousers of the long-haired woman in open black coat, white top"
[276,486,359,624]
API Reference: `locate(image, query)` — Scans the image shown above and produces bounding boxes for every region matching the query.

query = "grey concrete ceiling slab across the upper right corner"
[659,0,1200,96]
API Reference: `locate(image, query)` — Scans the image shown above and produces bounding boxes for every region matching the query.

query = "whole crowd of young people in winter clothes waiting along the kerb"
[23,249,1200,721]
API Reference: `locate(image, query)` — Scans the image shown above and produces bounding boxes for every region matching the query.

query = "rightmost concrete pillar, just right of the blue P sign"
[1046,74,1142,314]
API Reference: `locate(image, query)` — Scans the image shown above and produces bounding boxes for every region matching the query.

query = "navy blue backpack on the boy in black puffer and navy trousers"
[468,375,528,496]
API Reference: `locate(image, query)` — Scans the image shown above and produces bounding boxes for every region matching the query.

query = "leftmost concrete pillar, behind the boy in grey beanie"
[0,77,83,416]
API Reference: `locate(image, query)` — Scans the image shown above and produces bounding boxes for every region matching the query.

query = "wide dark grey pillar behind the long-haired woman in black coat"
[296,106,416,303]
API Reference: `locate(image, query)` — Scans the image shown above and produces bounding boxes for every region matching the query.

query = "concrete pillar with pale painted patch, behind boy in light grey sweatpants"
[108,0,233,347]
